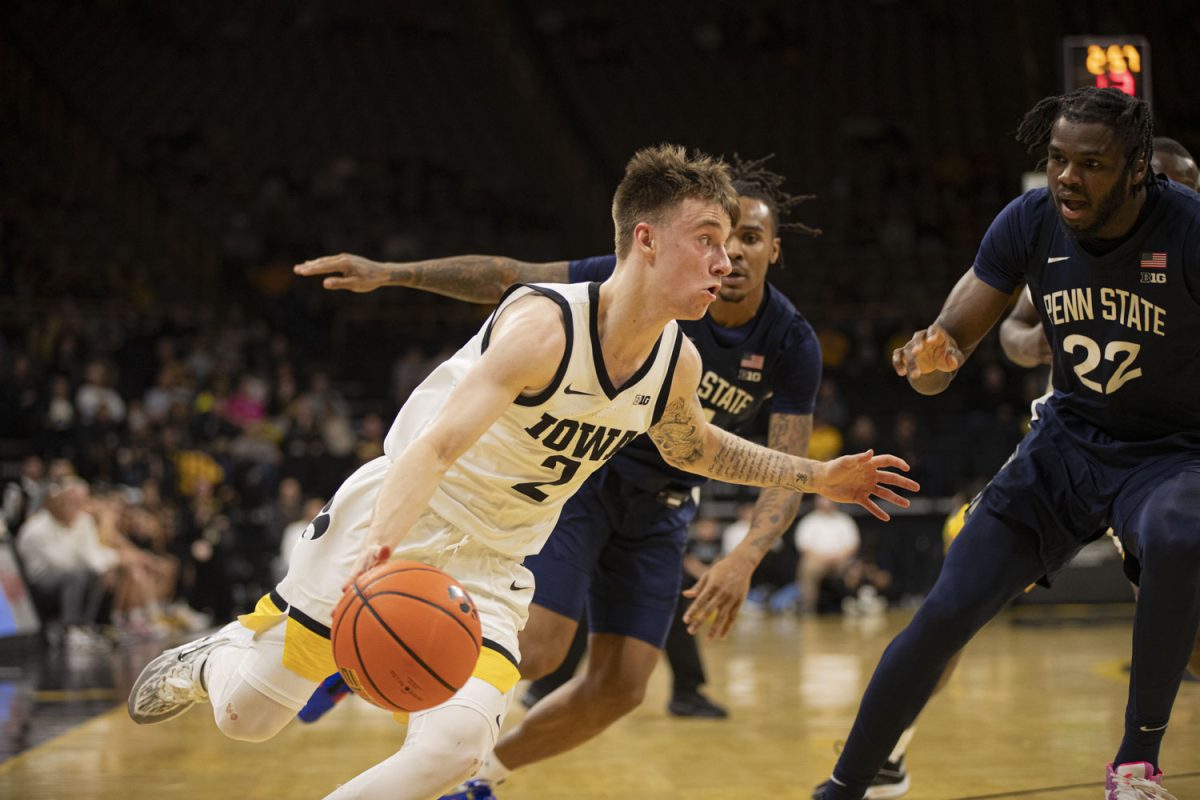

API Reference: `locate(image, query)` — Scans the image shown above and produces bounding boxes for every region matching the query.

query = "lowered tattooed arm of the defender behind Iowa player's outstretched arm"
[683,414,812,640]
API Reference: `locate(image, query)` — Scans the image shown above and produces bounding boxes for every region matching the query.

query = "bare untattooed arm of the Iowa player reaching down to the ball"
[352,296,566,577]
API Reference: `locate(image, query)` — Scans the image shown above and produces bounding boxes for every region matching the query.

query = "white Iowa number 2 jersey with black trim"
[384,283,682,559]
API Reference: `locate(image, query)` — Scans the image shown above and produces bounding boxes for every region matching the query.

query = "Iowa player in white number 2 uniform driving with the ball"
[128,145,918,800]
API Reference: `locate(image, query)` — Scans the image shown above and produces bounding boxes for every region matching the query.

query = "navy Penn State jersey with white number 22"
[974,182,1200,441]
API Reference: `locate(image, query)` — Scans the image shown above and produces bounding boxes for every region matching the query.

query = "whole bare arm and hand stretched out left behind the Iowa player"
[294,253,568,303]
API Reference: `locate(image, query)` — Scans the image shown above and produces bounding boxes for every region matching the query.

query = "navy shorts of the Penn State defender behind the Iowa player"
[524,465,696,648]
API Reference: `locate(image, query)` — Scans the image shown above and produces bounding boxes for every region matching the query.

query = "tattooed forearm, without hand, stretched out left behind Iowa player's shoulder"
[388,255,568,303]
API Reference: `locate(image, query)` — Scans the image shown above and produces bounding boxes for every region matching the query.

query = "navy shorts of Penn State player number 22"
[978,403,1200,582]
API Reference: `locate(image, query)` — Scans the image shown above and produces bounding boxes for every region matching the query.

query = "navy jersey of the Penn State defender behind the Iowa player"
[568,255,821,487]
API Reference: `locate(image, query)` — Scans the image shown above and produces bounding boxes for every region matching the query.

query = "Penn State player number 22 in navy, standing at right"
[815,89,1200,800]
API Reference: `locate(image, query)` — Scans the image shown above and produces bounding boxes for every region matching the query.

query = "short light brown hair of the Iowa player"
[612,144,738,258]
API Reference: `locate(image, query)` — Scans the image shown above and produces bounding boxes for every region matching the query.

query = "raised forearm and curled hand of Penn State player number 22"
[892,269,1020,395]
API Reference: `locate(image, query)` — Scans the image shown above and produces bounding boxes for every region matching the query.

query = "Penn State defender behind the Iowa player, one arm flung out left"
[296,157,821,799]
